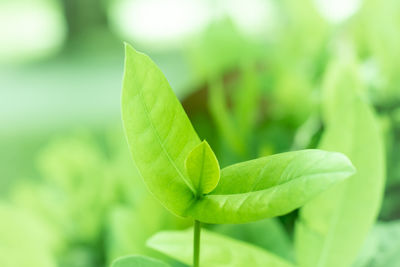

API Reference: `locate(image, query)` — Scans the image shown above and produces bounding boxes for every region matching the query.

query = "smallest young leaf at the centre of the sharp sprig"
[185,141,219,196]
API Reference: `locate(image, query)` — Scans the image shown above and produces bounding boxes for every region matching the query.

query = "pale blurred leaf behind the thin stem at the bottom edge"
[147,229,293,267]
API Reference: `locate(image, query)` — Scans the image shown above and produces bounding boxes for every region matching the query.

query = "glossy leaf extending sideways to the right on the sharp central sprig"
[187,150,354,223]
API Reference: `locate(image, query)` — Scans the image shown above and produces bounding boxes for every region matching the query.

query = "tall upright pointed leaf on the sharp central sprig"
[122,45,200,215]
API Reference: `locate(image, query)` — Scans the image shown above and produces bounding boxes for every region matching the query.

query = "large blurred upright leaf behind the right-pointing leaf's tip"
[296,59,385,267]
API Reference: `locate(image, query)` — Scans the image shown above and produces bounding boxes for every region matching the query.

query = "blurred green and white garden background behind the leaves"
[0,0,400,267]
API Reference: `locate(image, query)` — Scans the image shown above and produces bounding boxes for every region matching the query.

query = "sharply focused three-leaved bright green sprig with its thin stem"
[116,45,355,266]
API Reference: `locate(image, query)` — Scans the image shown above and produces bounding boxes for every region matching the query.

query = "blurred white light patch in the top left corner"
[0,1,66,62]
